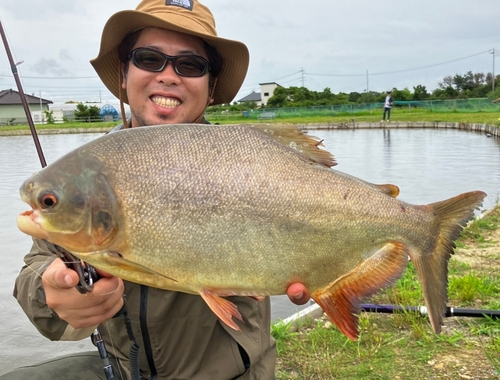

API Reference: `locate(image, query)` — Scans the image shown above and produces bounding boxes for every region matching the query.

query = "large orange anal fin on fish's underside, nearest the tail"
[311,242,408,340]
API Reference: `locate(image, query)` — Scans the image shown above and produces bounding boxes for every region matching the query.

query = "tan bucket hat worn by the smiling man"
[90,0,249,105]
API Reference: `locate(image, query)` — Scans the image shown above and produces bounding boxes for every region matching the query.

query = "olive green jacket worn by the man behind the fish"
[14,240,276,380]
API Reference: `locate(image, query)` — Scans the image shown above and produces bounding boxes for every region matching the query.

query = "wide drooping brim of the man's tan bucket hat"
[90,10,250,105]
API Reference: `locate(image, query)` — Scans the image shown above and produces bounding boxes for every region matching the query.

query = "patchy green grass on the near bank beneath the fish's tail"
[272,206,500,380]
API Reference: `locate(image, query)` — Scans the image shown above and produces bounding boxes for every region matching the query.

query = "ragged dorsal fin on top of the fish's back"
[252,125,337,168]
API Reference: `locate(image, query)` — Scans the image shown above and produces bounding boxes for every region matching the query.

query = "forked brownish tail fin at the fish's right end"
[410,191,486,334]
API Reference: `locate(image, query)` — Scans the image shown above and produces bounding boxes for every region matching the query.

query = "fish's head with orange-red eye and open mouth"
[17,152,119,252]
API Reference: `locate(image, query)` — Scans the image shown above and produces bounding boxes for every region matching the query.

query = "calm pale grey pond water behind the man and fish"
[0,129,500,374]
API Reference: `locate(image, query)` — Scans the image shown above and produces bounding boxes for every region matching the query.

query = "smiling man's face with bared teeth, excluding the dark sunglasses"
[122,28,215,127]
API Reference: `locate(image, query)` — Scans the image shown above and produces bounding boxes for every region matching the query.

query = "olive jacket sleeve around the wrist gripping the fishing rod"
[14,239,90,340]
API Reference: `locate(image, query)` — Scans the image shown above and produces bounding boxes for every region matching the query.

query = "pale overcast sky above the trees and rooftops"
[0,0,500,103]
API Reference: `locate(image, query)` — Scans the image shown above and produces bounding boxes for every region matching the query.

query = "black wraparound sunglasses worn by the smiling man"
[128,48,210,77]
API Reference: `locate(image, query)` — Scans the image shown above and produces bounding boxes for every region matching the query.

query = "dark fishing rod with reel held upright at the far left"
[0,20,117,380]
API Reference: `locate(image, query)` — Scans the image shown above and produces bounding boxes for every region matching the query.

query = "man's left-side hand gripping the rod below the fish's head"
[42,259,124,329]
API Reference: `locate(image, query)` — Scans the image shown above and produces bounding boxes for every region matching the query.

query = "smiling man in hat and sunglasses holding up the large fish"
[0,0,309,380]
